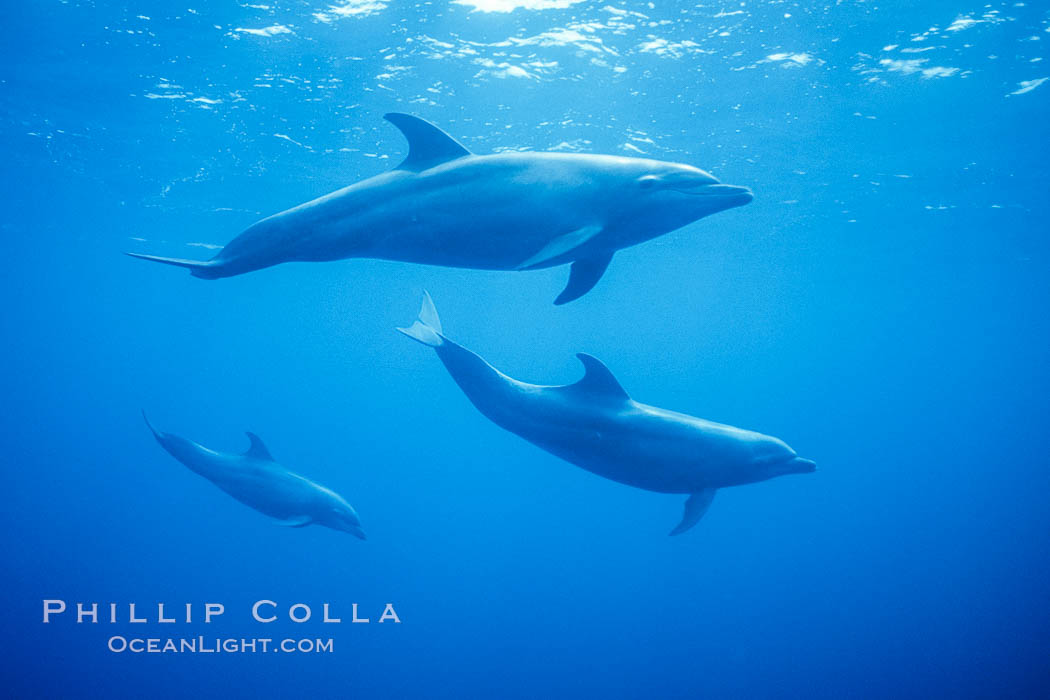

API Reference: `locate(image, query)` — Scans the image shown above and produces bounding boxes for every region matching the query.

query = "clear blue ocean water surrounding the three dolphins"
[0,0,1050,698]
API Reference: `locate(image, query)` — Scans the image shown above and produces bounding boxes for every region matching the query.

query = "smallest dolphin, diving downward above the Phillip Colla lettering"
[142,412,365,539]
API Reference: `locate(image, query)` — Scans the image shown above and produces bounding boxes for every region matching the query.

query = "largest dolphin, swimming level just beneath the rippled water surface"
[128,113,752,304]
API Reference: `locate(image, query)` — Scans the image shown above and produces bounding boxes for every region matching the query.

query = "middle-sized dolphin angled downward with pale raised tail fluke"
[398,294,817,535]
